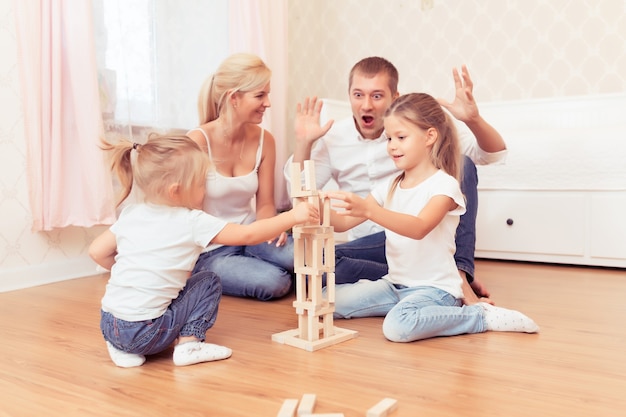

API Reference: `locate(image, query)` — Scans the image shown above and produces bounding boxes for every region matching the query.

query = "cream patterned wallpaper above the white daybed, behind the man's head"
[289,0,626,109]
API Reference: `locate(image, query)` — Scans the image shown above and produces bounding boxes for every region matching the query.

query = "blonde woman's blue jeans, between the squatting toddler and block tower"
[194,236,294,301]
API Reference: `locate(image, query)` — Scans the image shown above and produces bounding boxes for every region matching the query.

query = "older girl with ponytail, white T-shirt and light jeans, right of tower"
[326,93,539,342]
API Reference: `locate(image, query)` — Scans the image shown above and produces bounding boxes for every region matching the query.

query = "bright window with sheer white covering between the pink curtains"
[93,0,228,129]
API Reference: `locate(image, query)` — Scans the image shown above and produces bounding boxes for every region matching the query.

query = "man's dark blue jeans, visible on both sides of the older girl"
[335,156,478,284]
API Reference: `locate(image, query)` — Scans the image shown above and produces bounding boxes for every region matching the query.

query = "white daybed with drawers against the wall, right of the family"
[476,95,626,268]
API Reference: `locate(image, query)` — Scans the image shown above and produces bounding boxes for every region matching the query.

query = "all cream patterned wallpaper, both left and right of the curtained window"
[0,0,626,291]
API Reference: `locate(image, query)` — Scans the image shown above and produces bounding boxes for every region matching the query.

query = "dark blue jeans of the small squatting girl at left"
[100,271,222,355]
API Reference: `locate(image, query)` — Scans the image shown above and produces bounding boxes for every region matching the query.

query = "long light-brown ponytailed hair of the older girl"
[385,93,463,200]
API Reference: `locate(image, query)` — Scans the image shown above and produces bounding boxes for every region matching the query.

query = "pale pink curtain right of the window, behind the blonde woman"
[228,0,293,208]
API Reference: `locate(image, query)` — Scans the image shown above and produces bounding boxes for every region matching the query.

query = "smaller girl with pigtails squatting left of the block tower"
[89,135,319,367]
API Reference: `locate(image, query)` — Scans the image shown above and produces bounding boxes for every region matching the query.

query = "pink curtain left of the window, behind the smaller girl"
[15,0,115,231]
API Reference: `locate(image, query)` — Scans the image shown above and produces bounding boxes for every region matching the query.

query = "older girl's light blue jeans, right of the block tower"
[334,279,487,342]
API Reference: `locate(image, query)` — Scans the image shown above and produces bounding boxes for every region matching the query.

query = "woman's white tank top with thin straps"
[185,128,265,231]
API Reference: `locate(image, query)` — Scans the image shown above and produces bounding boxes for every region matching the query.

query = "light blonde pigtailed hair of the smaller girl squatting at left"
[101,133,210,208]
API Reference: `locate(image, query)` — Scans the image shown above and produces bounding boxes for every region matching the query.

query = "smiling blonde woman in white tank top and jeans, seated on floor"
[187,53,293,300]
